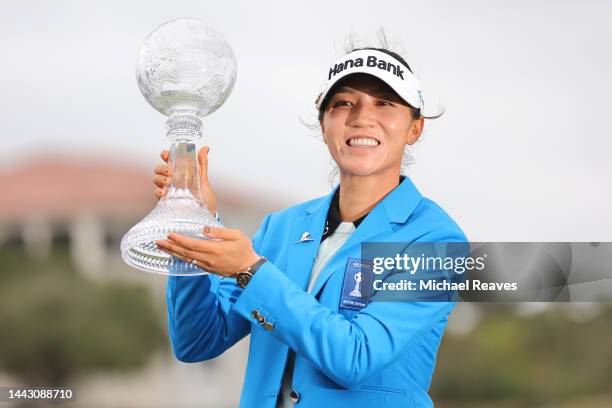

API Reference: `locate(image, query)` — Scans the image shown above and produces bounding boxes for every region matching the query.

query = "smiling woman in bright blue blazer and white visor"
[154,48,466,408]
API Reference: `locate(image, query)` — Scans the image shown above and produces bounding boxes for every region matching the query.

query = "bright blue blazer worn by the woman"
[167,177,467,408]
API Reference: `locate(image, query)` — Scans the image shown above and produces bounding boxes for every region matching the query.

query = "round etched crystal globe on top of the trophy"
[136,19,236,116]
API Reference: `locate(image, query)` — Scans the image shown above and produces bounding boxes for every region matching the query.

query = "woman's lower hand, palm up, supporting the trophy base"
[155,227,260,277]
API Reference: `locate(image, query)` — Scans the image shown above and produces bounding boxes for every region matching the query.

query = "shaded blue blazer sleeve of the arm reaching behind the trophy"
[166,214,270,363]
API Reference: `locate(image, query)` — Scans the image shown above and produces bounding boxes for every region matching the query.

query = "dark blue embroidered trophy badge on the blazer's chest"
[340,258,374,310]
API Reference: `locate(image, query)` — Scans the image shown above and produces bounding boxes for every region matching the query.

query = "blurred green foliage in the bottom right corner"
[432,304,612,406]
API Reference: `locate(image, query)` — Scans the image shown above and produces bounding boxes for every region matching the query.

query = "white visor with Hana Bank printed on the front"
[315,50,424,112]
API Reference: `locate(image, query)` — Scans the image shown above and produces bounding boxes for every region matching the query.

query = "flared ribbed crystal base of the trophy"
[121,196,223,276]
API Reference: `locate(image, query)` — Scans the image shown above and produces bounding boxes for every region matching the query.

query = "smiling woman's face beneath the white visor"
[321,74,424,188]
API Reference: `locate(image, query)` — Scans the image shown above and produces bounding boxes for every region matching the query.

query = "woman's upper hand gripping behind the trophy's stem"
[153,146,217,215]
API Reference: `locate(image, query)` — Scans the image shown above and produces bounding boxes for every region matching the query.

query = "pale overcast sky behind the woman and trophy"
[0,0,612,241]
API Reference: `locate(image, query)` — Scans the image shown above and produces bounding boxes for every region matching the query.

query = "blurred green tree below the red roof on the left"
[0,248,165,386]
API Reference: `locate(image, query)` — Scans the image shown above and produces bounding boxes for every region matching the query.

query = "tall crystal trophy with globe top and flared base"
[121,19,236,275]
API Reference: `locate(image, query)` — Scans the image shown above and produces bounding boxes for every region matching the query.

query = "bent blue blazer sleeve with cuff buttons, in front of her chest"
[234,226,466,388]
